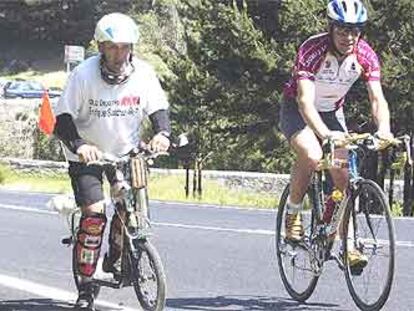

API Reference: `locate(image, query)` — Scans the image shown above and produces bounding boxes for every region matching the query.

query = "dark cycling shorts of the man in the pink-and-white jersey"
[279,100,348,140]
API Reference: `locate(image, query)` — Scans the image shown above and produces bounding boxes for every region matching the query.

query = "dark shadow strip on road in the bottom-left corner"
[0,299,73,311]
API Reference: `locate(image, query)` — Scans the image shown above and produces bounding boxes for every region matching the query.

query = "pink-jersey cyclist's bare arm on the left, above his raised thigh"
[297,79,331,139]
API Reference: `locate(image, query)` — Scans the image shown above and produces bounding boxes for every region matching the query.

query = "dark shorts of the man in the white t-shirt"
[69,161,114,206]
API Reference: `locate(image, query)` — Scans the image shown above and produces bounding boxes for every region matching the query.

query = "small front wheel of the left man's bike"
[130,239,167,311]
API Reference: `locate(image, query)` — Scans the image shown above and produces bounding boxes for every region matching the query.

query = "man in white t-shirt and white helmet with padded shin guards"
[55,13,171,310]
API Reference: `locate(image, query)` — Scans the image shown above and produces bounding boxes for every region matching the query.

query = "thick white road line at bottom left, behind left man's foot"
[0,274,140,311]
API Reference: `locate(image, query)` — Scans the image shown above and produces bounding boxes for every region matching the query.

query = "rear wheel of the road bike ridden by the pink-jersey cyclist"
[276,185,319,302]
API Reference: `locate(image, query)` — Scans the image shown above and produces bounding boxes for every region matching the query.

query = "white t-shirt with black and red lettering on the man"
[54,56,169,161]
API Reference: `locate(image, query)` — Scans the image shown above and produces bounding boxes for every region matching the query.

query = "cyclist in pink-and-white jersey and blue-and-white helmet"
[280,0,392,267]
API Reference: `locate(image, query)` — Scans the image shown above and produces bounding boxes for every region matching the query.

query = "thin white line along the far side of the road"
[0,204,414,248]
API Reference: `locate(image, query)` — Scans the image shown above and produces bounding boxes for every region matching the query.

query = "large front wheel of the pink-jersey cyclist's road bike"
[342,180,395,311]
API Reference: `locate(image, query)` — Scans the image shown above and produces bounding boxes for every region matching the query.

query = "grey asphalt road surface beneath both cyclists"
[0,190,414,311]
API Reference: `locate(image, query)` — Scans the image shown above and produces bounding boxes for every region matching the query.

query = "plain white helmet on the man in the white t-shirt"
[94,13,139,44]
